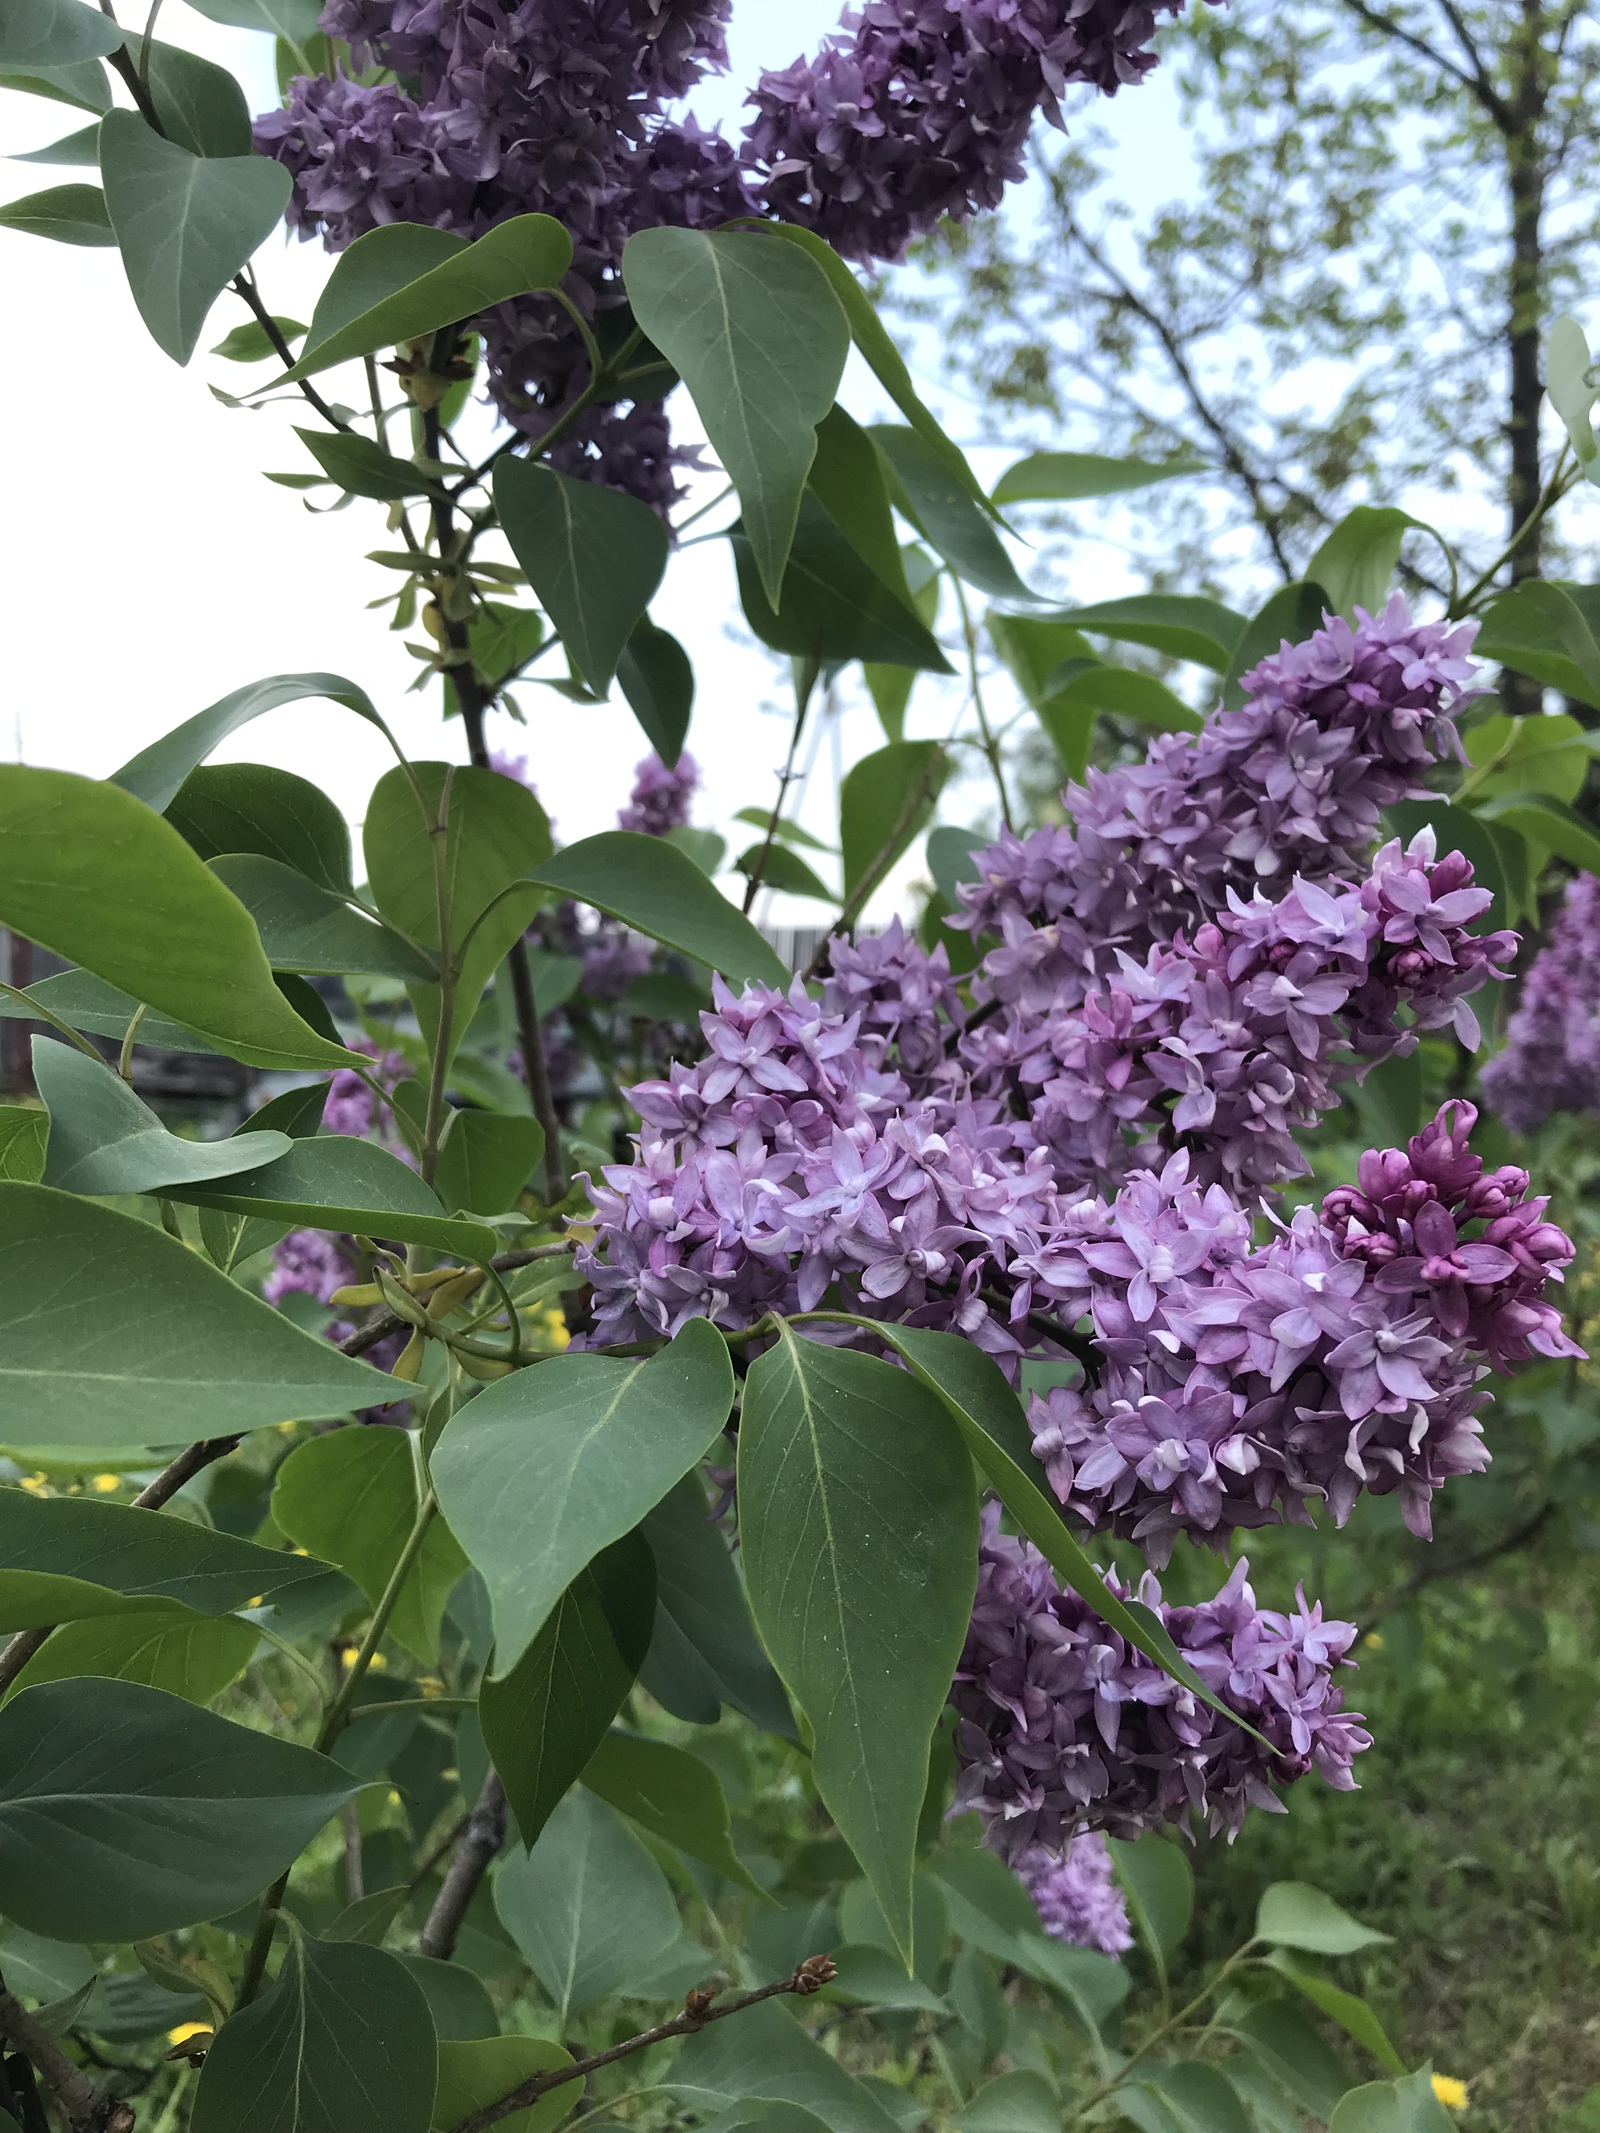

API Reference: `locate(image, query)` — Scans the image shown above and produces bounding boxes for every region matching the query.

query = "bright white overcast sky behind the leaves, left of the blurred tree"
[0,0,1175,924]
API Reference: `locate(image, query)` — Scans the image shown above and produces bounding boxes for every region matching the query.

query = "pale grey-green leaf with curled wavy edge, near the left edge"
[32,1037,294,1194]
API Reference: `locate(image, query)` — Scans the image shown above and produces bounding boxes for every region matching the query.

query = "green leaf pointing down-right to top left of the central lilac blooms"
[533,830,789,985]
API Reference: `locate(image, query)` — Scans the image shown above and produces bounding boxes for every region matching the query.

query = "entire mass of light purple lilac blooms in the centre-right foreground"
[578,602,1581,1851]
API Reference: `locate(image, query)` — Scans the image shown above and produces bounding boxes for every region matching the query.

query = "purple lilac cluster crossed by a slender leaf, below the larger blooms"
[951,1506,1372,1862]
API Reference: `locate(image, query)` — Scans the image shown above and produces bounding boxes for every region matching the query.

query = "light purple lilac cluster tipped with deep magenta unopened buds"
[1020,1103,1581,1561]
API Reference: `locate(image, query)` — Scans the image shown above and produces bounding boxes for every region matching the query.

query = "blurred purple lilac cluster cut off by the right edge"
[1483,875,1600,1133]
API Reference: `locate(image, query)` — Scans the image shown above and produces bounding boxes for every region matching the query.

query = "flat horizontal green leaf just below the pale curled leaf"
[169,1133,499,1261]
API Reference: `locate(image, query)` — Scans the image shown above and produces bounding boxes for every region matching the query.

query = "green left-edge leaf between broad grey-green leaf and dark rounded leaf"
[0,1489,326,1630]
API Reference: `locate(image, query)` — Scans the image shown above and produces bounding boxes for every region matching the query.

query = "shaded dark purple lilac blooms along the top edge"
[256,0,1182,508]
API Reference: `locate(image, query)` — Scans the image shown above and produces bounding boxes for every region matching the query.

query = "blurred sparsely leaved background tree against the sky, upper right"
[898,0,1600,648]
